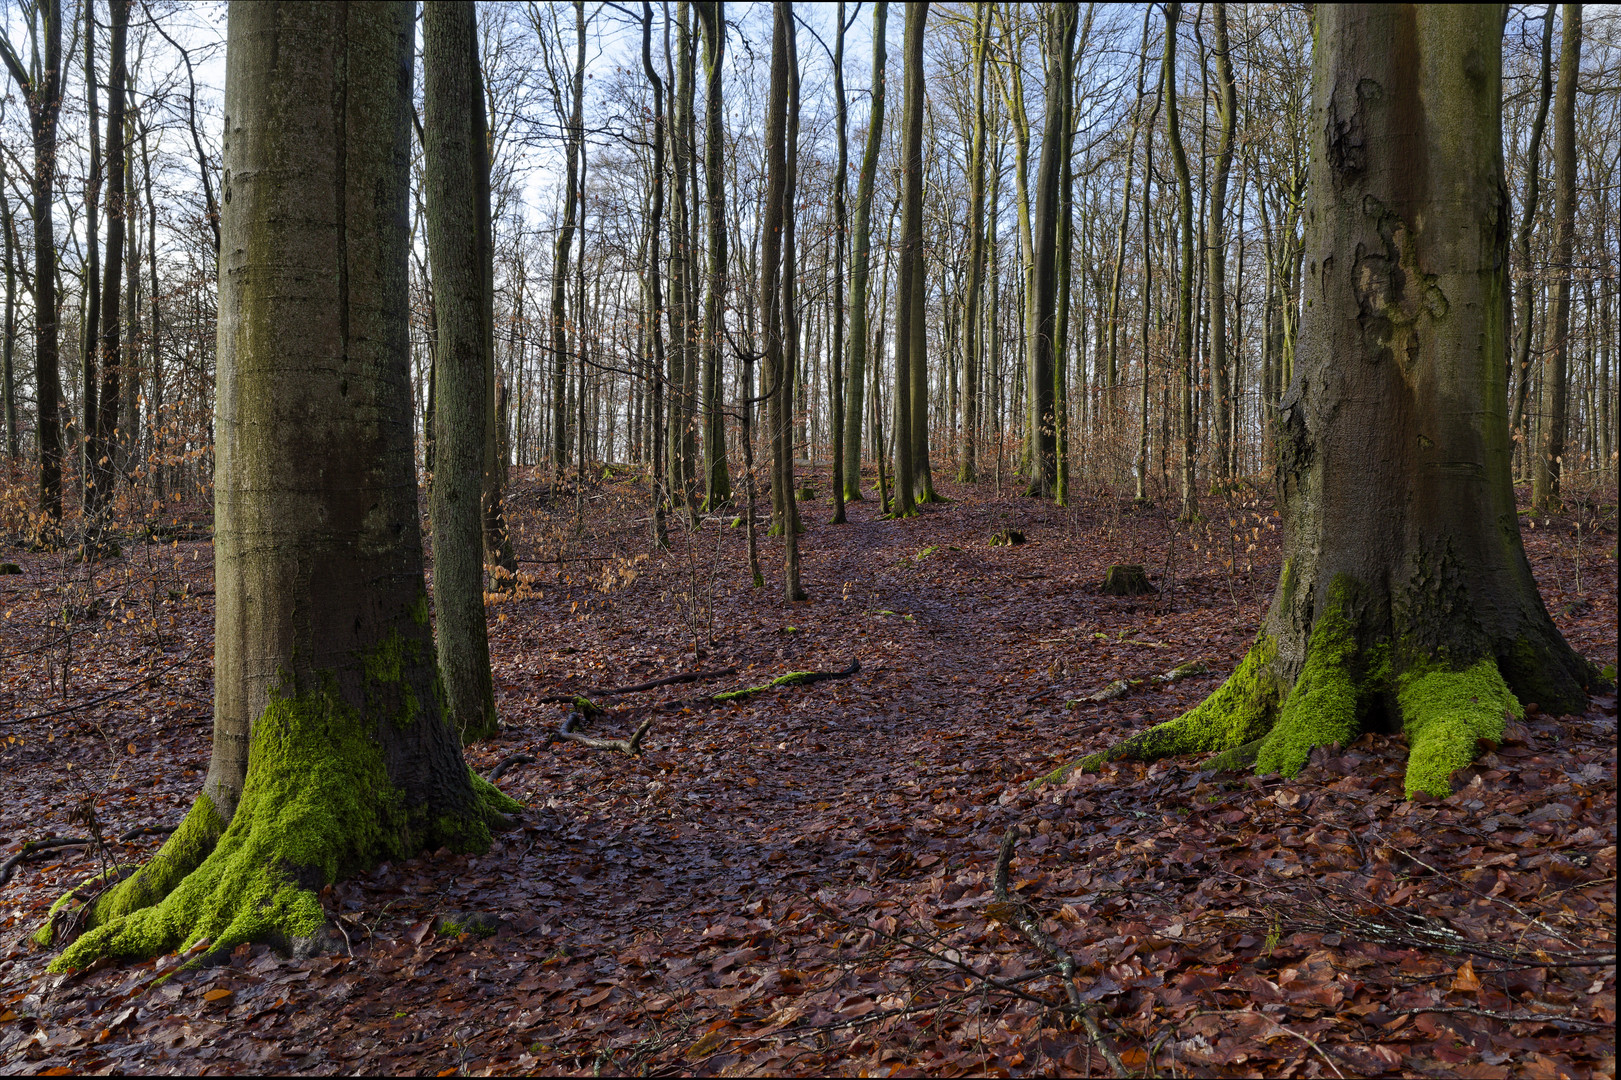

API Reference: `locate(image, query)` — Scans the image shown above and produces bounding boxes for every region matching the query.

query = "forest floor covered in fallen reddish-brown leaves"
[0,463,1616,1078]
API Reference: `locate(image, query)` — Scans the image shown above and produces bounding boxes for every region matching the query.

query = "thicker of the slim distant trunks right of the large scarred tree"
[1530,3,1582,514]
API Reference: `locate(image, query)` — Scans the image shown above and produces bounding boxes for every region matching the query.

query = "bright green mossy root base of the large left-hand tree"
[41,683,519,971]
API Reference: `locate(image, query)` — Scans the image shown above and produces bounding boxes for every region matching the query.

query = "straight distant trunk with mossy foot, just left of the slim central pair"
[697,0,731,511]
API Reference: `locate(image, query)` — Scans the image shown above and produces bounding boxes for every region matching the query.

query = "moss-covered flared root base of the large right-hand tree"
[1044,579,1588,798]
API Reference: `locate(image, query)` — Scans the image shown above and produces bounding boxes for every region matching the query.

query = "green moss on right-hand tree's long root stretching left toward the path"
[1036,634,1279,783]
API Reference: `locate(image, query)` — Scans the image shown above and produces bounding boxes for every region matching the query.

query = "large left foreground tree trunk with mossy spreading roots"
[53,3,515,970]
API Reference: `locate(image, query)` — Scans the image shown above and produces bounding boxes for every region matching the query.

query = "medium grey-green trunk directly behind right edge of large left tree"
[421,0,498,741]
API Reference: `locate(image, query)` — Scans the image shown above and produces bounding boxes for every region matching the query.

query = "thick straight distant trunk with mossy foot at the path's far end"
[893,3,929,517]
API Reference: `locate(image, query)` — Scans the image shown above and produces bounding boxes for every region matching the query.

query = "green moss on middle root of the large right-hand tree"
[1255,574,1365,777]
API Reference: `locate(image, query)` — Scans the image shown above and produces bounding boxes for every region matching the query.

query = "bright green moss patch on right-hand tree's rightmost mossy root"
[1397,657,1524,798]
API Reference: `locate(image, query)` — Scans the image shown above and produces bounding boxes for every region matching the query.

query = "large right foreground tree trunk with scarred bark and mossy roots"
[1083,5,1600,795]
